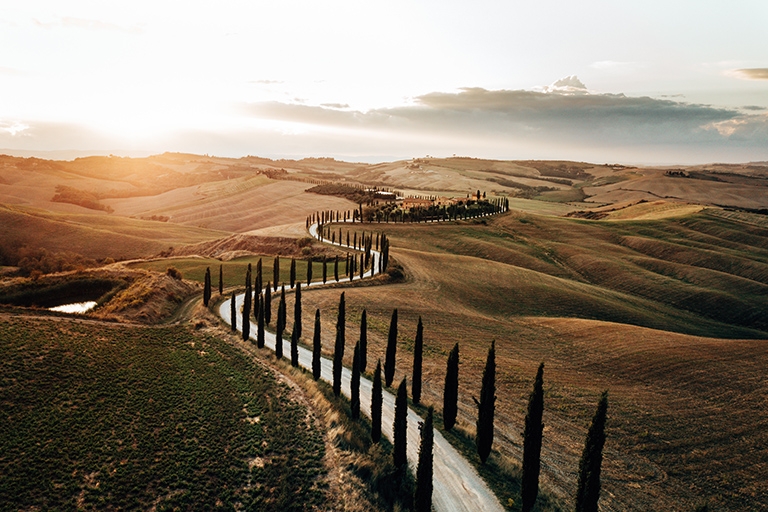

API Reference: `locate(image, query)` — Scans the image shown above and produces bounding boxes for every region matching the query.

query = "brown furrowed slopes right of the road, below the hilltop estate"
[288,210,768,511]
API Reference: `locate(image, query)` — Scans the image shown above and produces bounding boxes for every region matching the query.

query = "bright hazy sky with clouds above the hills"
[0,0,768,164]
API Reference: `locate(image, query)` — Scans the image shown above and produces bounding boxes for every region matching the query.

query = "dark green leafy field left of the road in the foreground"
[0,317,324,511]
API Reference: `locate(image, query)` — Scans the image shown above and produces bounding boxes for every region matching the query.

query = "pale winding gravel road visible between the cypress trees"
[219,224,504,512]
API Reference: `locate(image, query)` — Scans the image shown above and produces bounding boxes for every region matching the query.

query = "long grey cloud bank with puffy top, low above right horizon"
[236,82,768,162]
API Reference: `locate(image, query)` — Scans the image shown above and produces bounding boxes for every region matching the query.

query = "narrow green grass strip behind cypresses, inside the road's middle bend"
[128,256,347,288]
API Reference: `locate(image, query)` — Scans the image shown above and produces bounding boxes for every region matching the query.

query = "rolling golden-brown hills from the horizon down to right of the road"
[0,150,768,512]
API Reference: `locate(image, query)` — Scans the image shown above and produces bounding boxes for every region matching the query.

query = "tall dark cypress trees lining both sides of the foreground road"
[210,250,607,512]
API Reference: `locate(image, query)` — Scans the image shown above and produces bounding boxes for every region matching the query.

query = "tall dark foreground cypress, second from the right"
[520,363,544,512]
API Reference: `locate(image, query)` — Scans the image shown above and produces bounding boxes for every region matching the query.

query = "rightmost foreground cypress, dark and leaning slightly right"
[576,391,608,512]
